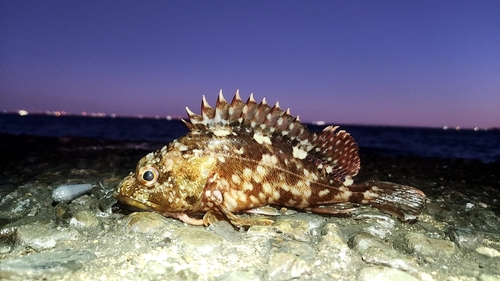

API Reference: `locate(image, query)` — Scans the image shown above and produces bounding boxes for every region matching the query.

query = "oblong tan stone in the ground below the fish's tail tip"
[405,233,457,259]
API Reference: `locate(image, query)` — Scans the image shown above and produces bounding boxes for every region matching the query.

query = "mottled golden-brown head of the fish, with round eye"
[113,143,216,214]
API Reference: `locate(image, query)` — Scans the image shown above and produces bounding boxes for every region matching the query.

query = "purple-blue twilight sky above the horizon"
[0,0,500,128]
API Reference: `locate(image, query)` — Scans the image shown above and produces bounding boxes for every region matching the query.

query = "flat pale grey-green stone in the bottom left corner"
[0,250,97,280]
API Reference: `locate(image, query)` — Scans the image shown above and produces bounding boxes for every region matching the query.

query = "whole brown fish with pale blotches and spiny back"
[113,90,425,227]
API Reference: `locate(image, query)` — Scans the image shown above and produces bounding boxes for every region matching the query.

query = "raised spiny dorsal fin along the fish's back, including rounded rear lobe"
[184,90,360,177]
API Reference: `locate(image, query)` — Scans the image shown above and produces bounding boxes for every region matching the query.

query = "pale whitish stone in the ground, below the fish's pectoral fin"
[172,226,224,256]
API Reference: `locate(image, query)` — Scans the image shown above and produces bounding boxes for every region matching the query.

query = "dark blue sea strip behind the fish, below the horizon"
[0,114,500,163]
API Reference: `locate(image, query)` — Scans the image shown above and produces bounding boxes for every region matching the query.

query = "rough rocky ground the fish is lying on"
[0,132,500,281]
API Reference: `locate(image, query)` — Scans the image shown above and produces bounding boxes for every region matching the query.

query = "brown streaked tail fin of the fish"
[350,181,425,222]
